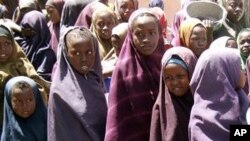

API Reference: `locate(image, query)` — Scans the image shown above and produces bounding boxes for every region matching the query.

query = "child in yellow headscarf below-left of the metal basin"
[180,18,208,58]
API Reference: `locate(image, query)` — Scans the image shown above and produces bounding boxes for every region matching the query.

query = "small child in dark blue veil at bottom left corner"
[1,76,47,141]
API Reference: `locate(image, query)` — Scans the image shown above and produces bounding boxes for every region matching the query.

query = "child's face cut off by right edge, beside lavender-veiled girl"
[239,32,250,56]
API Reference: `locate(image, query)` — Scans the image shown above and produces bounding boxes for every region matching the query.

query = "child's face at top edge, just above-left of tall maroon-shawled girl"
[119,0,135,22]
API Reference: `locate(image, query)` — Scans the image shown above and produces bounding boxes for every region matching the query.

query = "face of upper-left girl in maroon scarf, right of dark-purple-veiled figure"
[45,6,60,24]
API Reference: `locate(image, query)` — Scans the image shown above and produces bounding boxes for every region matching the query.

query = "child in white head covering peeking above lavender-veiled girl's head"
[209,36,237,49]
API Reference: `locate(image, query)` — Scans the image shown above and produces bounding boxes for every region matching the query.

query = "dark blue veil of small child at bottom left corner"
[1,76,47,141]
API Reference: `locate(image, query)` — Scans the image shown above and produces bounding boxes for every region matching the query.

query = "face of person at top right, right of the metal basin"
[225,0,243,22]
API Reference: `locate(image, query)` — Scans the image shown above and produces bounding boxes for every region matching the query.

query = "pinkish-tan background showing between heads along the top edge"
[110,0,180,27]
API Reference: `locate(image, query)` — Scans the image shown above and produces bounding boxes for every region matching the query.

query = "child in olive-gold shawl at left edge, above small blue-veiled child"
[0,25,50,127]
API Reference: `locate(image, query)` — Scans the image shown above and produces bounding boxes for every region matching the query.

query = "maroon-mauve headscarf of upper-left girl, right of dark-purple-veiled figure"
[46,0,64,54]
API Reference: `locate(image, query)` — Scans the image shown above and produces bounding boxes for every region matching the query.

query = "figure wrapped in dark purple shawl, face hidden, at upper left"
[16,10,56,81]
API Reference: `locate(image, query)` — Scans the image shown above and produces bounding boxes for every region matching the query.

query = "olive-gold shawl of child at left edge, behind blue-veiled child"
[0,37,49,104]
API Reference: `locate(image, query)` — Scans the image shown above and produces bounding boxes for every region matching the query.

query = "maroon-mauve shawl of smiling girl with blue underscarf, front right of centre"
[150,47,197,141]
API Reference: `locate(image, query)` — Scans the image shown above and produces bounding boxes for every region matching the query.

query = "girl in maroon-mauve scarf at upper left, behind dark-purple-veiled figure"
[45,0,64,54]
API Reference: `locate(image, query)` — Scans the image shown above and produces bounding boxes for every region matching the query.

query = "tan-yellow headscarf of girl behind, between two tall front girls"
[91,8,117,60]
